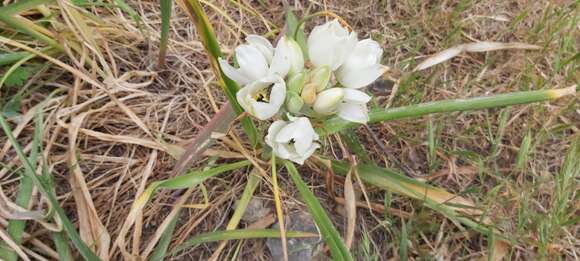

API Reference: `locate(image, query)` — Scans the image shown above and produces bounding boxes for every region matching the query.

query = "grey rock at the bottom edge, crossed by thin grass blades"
[266,212,321,261]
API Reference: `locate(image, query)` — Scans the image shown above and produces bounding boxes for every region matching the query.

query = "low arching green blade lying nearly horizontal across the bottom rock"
[171,229,317,254]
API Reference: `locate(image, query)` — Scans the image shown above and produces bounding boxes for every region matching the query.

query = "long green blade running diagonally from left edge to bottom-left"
[0,114,100,261]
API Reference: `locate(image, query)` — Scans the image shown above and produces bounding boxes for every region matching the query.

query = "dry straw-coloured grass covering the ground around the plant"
[0,0,580,260]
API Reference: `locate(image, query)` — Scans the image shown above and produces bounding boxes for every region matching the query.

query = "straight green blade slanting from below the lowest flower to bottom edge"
[285,161,353,260]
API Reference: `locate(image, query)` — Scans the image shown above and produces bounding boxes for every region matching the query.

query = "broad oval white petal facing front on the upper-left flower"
[236,44,268,81]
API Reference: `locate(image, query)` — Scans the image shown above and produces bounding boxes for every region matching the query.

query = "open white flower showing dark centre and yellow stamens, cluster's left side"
[236,74,286,120]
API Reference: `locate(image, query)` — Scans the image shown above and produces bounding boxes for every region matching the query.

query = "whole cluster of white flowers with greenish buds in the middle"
[219,20,386,164]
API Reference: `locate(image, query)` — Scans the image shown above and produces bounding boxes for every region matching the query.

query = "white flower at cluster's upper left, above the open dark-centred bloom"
[218,35,304,86]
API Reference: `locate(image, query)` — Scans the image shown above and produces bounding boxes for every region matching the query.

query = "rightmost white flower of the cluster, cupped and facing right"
[335,39,387,88]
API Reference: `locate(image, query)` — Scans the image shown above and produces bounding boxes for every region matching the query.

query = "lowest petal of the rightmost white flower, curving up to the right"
[335,64,387,89]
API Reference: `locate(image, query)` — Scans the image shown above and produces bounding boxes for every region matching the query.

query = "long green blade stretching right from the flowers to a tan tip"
[321,86,576,134]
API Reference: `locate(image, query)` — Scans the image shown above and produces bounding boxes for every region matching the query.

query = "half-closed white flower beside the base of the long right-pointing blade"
[312,87,371,124]
